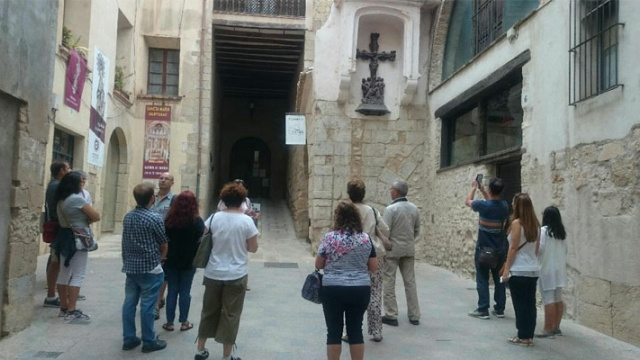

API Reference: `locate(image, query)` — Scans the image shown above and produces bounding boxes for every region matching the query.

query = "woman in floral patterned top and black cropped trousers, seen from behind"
[316,202,378,360]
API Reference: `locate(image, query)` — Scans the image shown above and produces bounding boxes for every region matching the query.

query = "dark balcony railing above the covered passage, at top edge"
[213,0,306,17]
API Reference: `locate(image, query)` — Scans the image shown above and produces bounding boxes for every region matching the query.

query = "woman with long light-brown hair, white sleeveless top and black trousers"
[500,194,540,346]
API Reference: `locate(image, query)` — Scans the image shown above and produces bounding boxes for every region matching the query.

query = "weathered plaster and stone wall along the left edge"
[0,1,58,336]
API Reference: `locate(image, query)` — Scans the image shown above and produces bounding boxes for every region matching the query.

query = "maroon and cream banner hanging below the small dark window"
[142,105,171,179]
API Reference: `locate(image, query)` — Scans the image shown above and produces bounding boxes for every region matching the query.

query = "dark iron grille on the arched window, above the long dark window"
[471,0,504,54]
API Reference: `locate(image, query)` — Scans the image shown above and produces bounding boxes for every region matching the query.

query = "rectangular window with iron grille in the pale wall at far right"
[569,0,624,105]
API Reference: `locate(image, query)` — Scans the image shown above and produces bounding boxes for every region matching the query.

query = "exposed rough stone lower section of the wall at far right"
[540,125,640,344]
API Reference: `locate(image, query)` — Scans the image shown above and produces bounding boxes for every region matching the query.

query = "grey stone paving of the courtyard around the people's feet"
[0,200,640,360]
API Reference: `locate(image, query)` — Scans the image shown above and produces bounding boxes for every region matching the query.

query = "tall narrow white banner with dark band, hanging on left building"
[87,46,109,167]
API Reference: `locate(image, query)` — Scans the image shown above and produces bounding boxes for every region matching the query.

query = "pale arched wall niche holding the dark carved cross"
[314,0,425,120]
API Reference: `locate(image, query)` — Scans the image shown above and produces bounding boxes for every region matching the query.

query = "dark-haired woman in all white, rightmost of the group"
[536,206,567,339]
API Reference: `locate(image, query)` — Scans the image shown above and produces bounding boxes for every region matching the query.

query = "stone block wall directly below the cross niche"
[307,101,427,253]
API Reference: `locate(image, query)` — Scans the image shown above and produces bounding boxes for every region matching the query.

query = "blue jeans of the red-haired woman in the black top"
[165,268,196,323]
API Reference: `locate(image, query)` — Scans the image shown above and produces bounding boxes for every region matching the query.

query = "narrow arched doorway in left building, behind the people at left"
[102,128,129,233]
